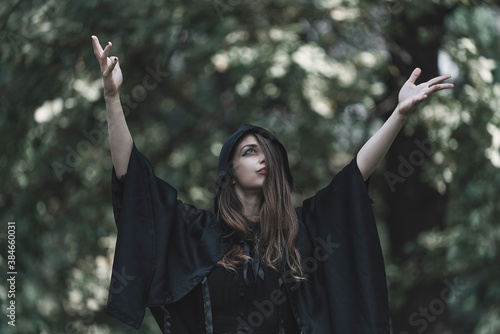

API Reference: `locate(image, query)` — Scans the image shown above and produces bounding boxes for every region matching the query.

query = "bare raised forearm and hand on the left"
[92,36,133,178]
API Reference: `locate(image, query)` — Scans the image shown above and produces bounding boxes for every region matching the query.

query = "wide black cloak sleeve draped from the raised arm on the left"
[107,144,231,328]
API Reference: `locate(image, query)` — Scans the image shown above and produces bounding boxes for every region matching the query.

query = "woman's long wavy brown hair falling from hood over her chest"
[216,132,304,281]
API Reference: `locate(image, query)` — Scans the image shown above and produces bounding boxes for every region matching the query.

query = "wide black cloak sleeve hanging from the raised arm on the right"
[287,158,390,334]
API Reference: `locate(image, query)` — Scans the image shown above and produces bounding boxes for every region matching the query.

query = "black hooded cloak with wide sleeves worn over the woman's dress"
[107,124,390,334]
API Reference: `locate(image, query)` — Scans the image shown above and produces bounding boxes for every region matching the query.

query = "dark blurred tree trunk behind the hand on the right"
[366,2,458,333]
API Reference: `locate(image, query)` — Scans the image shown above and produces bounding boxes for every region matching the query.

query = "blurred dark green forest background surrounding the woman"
[0,0,500,334]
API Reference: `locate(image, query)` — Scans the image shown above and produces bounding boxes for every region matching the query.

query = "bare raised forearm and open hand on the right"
[356,68,453,180]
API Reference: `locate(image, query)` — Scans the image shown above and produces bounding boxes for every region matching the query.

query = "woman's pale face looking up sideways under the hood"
[233,133,266,192]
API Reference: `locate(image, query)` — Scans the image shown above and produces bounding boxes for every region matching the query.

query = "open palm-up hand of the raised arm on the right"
[398,68,453,116]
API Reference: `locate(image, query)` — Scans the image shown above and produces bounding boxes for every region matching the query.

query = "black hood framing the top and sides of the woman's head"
[214,124,293,205]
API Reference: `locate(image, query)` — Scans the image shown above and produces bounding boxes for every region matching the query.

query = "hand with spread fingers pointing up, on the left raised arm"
[92,36,123,97]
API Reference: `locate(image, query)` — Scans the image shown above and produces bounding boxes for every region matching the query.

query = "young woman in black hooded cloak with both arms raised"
[92,36,453,334]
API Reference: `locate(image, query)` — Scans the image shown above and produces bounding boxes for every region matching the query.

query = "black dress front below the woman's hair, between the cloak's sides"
[152,240,301,334]
